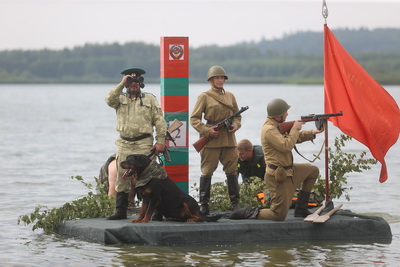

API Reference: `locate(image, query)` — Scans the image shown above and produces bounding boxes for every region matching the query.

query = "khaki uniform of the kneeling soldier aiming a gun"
[257,118,319,221]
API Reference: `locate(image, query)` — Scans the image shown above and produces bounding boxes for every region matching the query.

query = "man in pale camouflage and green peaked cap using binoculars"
[105,68,167,220]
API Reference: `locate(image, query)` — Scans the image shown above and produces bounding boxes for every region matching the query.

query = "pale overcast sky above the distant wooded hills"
[0,0,400,50]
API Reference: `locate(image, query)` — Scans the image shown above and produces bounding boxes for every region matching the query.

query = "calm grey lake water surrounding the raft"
[0,82,400,266]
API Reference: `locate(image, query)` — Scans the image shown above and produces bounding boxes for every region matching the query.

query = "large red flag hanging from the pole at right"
[324,25,400,183]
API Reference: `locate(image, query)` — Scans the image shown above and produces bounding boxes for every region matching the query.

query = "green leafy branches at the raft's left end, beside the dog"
[18,176,115,233]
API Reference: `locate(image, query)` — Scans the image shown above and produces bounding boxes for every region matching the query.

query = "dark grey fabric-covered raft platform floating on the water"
[57,210,392,246]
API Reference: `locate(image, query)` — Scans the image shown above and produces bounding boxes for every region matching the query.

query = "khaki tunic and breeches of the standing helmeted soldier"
[190,88,241,176]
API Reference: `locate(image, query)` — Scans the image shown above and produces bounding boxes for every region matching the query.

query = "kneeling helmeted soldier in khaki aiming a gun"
[230,99,324,221]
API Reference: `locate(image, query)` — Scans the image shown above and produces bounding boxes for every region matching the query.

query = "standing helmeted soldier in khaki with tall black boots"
[190,66,241,217]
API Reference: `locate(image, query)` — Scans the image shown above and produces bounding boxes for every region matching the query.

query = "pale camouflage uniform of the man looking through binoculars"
[106,83,167,193]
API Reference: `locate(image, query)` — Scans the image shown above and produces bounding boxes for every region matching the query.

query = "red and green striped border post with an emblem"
[160,37,189,193]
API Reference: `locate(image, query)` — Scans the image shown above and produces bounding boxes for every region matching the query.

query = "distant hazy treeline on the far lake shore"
[0,28,400,84]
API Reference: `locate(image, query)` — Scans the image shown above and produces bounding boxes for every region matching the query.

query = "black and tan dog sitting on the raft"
[120,154,222,223]
